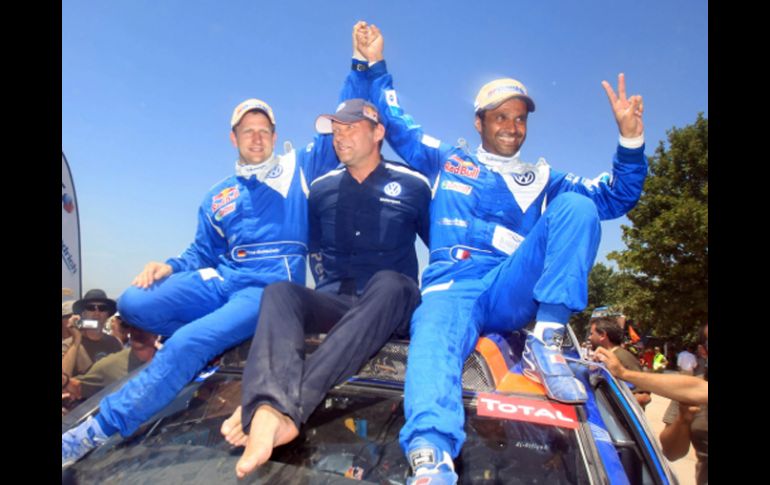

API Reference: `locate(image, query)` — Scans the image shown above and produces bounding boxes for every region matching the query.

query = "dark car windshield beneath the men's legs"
[67,373,590,484]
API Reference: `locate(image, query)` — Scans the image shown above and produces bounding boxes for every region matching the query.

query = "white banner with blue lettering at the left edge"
[61,152,83,300]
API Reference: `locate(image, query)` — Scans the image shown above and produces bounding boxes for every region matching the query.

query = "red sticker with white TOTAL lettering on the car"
[476,393,580,429]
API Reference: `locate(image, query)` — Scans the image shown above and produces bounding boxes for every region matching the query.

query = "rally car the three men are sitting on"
[62,331,678,485]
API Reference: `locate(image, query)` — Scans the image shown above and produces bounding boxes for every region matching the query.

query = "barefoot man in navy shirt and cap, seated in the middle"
[222,94,431,478]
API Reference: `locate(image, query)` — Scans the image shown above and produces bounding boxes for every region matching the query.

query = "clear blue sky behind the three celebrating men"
[62,0,708,297]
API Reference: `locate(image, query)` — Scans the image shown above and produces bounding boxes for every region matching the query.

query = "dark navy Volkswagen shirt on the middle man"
[309,160,431,293]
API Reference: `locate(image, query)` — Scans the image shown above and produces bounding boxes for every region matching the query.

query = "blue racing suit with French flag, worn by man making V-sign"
[368,61,647,457]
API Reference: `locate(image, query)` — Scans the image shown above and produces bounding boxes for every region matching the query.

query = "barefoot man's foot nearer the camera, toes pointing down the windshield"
[235,404,299,478]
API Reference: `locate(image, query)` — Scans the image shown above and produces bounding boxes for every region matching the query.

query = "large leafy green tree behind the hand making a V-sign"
[608,113,708,340]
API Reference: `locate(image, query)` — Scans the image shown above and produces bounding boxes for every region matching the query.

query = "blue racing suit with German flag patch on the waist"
[97,64,365,436]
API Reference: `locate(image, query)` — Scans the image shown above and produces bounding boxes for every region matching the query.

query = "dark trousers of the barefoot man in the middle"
[241,271,420,433]
